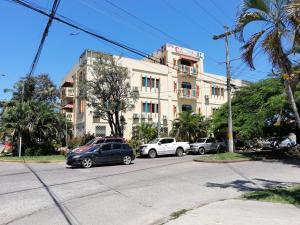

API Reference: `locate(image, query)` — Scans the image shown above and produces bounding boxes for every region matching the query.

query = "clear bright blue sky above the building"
[0,0,271,99]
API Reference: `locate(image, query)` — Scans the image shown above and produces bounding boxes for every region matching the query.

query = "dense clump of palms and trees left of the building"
[0,75,71,154]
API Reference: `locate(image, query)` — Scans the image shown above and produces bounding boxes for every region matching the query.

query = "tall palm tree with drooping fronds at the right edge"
[235,0,300,128]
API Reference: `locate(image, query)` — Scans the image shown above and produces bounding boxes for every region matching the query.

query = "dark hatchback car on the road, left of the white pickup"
[67,143,135,168]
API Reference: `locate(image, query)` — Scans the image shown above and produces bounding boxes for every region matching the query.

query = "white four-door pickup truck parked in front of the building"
[139,138,190,158]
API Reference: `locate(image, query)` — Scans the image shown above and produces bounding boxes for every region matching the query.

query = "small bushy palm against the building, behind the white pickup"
[170,111,209,142]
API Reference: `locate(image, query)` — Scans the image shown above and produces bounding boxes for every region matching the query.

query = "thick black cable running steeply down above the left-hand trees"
[29,0,60,75]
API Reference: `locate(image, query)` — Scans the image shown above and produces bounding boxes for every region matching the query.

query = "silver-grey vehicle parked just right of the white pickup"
[188,137,226,155]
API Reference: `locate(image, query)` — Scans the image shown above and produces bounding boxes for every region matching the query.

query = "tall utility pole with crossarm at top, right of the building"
[213,26,237,152]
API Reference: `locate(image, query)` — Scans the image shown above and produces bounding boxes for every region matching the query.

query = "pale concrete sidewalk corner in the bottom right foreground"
[166,200,300,225]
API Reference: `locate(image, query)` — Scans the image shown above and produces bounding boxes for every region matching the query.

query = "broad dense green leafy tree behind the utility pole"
[212,78,300,139]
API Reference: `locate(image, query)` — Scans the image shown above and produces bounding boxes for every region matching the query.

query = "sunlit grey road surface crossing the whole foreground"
[0,155,300,225]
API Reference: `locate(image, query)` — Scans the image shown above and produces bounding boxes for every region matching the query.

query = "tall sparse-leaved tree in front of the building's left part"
[80,53,138,136]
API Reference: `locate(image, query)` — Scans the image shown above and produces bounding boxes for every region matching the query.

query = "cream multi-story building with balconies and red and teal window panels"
[61,44,247,138]
